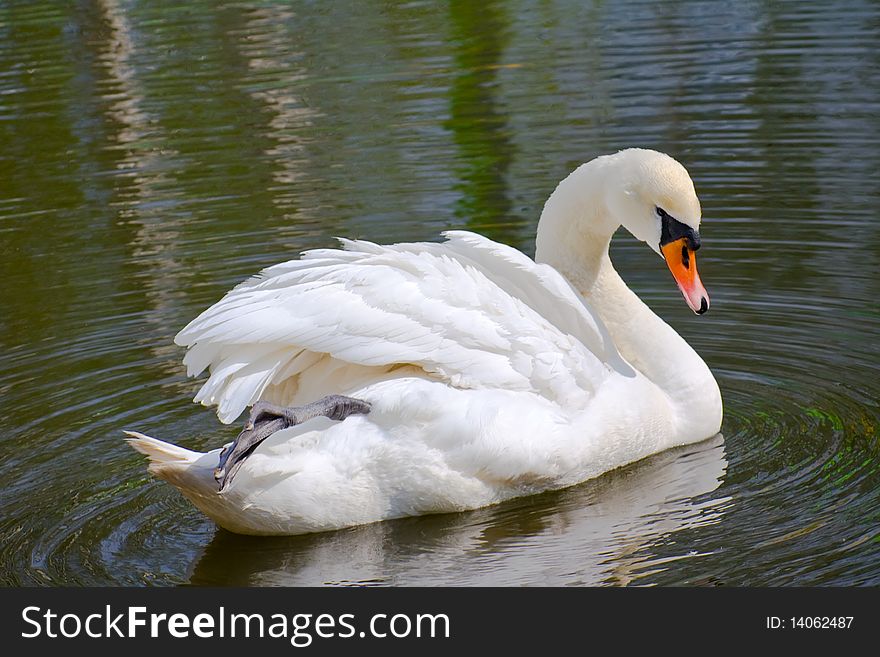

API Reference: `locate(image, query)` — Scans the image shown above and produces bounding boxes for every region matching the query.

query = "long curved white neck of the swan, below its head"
[535,158,714,430]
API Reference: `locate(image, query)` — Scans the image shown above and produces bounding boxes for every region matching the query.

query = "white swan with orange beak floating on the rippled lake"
[128,149,722,534]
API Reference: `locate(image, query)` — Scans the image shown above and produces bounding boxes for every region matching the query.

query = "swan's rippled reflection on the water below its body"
[190,436,731,586]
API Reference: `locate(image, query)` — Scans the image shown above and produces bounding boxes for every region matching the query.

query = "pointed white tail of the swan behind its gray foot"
[125,431,217,496]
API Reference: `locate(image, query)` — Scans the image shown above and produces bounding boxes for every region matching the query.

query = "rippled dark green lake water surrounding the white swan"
[0,0,880,585]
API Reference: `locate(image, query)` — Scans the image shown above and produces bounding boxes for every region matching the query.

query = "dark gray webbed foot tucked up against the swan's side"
[214,395,371,493]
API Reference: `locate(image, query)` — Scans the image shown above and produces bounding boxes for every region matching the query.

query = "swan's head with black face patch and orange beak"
[605,148,709,315]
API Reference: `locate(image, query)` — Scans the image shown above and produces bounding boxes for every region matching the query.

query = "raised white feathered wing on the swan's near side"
[175,231,626,422]
